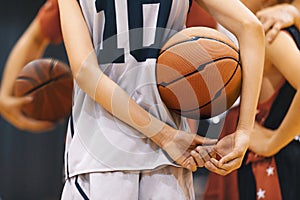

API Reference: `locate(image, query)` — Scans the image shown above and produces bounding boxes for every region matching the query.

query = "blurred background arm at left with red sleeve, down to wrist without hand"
[0,0,62,99]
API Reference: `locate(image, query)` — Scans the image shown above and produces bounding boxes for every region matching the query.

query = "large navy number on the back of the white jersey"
[95,0,172,64]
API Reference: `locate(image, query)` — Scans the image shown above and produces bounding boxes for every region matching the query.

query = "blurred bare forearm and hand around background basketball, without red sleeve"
[0,20,53,132]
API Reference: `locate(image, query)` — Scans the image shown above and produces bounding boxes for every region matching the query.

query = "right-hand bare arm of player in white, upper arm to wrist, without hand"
[197,0,265,132]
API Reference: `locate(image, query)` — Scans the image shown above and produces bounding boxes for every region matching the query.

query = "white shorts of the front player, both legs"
[62,166,195,200]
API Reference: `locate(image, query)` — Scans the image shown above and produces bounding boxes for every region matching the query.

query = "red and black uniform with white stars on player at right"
[203,26,300,200]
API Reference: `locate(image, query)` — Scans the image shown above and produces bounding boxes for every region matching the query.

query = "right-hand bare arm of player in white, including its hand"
[197,0,265,174]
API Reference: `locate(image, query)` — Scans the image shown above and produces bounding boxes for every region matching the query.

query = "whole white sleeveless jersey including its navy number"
[65,0,189,177]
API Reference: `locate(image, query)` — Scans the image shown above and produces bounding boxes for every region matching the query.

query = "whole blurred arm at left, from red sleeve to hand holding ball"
[0,0,62,132]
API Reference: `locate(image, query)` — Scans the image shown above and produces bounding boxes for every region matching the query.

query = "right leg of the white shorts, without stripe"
[139,166,195,200]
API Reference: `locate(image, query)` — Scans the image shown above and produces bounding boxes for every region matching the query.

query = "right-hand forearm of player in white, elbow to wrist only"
[237,24,265,133]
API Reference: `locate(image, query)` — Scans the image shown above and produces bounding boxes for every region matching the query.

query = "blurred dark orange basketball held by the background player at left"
[14,58,73,122]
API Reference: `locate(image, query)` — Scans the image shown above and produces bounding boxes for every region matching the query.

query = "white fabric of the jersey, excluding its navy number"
[65,0,189,177]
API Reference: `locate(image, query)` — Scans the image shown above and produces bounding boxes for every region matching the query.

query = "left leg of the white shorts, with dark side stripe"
[62,172,139,200]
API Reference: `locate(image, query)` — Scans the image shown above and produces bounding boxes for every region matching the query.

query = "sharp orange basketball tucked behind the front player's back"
[156,27,242,119]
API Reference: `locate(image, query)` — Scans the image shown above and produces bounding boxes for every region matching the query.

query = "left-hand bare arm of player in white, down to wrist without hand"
[59,0,175,146]
